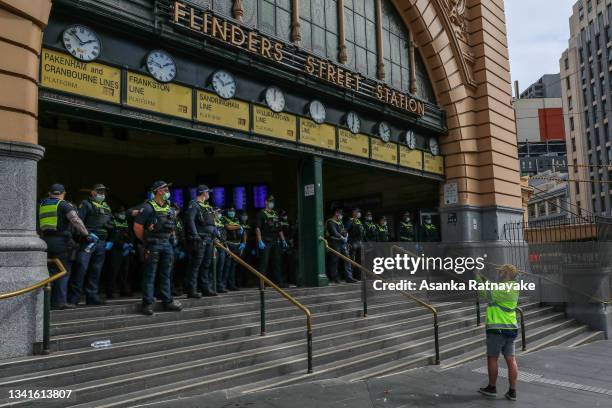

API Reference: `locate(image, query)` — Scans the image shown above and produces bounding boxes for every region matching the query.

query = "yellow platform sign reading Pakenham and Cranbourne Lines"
[40,49,121,103]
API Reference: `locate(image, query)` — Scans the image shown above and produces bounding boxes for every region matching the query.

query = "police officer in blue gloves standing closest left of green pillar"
[255,195,288,287]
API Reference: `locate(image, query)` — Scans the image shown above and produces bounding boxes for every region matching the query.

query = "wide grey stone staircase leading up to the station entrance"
[0,284,603,407]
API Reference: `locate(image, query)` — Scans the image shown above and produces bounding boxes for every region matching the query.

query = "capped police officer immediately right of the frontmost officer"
[184,184,217,298]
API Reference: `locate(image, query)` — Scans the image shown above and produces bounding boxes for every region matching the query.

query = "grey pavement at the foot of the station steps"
[141,341,612,408]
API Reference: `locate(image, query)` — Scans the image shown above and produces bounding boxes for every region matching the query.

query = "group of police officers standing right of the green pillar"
[325,208,440,283]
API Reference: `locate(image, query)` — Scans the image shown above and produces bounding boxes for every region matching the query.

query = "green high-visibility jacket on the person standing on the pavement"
[476,277,519,330]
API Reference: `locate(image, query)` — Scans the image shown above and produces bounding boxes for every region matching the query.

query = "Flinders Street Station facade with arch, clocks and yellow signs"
[0,0,522,355]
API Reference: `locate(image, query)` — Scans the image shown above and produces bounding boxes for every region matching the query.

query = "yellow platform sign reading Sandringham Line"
[196,91,250,132]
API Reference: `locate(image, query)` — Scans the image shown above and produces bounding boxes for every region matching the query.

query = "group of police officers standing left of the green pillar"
[38,181,293,315]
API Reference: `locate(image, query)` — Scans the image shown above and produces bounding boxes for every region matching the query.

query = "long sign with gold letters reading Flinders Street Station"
[169,1,425,116]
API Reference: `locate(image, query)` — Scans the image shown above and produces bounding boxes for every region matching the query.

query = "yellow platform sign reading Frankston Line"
[127,72,193,119]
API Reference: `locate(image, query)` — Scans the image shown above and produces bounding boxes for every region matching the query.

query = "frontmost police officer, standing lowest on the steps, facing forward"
[134,180,183,315]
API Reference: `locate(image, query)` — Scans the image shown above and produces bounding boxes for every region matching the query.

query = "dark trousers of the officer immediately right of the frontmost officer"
[185,237,215,293]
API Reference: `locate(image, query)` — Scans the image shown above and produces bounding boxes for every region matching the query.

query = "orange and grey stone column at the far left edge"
[0,0,51,359]
